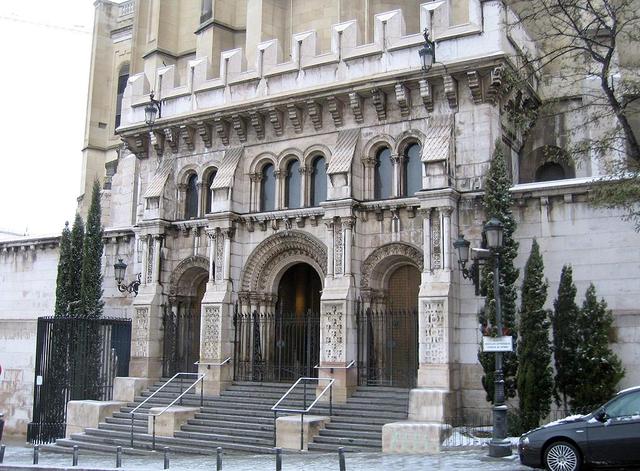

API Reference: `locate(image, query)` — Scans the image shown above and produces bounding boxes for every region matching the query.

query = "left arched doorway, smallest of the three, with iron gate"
[162,266,209,376]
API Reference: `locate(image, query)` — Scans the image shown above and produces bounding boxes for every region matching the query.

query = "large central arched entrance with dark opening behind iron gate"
[234,262,322,383]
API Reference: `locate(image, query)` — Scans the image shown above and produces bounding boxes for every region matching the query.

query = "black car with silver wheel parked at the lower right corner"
[518,386,640,471]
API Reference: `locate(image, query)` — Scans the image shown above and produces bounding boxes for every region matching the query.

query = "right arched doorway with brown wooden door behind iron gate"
[357,243,422,388]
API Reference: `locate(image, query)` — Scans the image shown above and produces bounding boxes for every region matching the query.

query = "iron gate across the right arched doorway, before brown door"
[356,307,418,388]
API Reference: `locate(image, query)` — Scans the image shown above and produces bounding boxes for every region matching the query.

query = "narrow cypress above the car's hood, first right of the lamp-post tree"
[517,239,553,430]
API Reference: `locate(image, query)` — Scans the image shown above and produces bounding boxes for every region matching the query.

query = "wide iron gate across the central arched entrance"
[233,306,320,382]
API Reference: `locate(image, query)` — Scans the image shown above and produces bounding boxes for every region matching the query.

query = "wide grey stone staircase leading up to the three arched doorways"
[41,380,409,454]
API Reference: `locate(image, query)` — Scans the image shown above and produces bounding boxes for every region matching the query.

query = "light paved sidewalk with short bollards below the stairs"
[0,443,530,471]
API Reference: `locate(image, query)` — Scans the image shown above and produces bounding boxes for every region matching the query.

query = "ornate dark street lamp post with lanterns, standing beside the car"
[453,218,511,457]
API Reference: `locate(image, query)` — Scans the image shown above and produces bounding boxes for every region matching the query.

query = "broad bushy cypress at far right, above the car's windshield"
[571,283,624,412]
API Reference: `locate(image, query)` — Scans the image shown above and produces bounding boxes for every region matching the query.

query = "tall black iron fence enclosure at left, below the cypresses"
[27,317,131,443]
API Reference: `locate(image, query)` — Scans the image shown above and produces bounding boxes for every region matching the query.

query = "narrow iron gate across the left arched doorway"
[162,307,200,377]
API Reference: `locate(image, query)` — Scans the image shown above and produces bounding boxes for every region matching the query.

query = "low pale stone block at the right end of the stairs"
[382,421,451,454]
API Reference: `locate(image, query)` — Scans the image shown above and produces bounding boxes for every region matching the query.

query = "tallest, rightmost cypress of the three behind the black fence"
[80,180,104,318]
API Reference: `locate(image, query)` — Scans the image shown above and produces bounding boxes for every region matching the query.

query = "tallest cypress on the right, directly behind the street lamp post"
[478,143,518,402]
